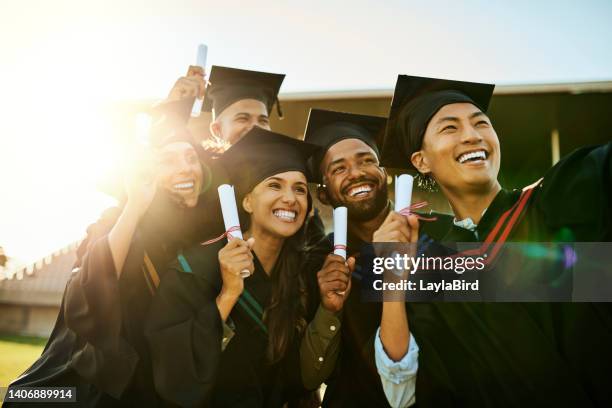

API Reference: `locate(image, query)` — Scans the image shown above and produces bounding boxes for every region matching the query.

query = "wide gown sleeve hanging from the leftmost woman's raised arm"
[60,208,142,398]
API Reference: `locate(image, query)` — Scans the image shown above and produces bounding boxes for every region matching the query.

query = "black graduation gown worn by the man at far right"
[408,143,612,407]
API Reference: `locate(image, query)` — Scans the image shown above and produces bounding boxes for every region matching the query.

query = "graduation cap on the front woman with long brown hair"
[219,126,318,196]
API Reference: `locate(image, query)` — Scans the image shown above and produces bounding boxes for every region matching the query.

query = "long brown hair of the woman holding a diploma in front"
[238,192,312,363]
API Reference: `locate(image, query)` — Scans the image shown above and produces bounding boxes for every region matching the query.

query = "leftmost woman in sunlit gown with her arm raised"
[1,95,230,405]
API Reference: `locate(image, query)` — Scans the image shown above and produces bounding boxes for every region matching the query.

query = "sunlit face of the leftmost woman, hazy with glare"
[158,142,203,207]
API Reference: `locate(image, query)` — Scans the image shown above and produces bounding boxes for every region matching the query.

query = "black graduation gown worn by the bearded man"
[322,209,452,407]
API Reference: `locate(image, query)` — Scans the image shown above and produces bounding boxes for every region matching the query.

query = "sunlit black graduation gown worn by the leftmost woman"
[5,186,222,406]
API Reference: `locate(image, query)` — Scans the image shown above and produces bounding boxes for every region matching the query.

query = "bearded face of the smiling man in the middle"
[321,139,388,221]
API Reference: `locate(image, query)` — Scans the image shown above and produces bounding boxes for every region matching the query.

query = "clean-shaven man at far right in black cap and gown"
[383,75,612,406]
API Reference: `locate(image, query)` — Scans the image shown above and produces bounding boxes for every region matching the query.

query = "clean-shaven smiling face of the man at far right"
[412,103,501,192]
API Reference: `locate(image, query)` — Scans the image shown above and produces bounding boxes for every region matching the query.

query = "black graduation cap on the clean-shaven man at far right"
[381,75,495,168]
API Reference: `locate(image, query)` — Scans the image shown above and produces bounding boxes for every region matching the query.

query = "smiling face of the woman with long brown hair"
[243,171,308,238]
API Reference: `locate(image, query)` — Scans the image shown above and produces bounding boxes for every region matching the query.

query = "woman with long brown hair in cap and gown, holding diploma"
[147,128,319,406]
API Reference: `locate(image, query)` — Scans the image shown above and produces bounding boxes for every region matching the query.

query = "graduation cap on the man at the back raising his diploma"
[202,65,285,117]
